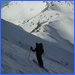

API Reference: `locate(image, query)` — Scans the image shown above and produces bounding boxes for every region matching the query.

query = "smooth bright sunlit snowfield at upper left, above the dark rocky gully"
[2,1,46,24]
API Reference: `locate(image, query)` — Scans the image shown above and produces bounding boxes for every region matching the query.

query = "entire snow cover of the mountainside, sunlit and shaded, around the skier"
[1,1,74,74]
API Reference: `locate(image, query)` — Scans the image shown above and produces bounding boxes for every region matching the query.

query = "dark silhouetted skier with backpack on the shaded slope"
[31,43,44,67]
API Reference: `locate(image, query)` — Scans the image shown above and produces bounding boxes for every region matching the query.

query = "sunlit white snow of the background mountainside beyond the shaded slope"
[2,1,74,44]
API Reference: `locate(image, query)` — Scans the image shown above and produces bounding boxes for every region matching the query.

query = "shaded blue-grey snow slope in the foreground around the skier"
[2,20,73,73]
